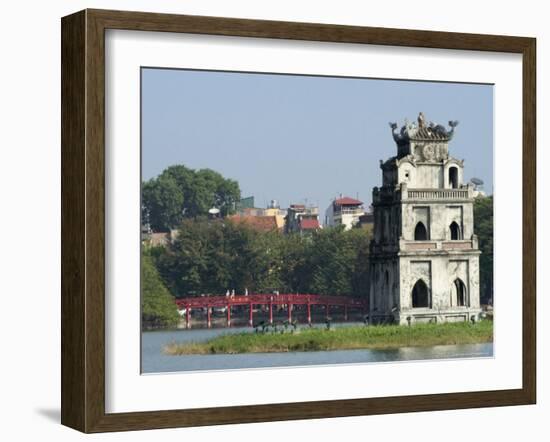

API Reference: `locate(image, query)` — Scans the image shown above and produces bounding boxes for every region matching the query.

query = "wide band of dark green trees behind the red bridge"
[155,219,370,296]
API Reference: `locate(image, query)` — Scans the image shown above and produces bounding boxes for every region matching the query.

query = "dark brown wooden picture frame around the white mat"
[61,10,536,432]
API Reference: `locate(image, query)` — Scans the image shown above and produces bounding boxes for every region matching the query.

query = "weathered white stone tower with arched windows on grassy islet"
[369,113,481,324]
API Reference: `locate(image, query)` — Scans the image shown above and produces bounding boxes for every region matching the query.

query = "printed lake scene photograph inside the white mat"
[136,67,495,373]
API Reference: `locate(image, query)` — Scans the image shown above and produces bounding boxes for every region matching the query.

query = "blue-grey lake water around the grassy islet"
[141,323,493,373]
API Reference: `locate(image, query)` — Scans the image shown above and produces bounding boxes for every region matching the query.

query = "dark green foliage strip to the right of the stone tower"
[474,195,493,304]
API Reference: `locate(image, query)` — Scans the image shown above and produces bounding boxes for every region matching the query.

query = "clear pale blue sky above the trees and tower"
[142,68,493,218]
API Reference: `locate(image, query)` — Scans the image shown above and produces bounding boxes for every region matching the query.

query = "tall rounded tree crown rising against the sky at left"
[142,165,241,232]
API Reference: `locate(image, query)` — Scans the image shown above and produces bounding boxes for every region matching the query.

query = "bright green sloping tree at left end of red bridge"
[141,253,179,328]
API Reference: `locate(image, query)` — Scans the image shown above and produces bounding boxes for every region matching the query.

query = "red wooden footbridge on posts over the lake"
[176,294,367,328]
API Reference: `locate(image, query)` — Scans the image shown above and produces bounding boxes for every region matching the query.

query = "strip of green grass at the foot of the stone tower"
[163,320,493,356]
